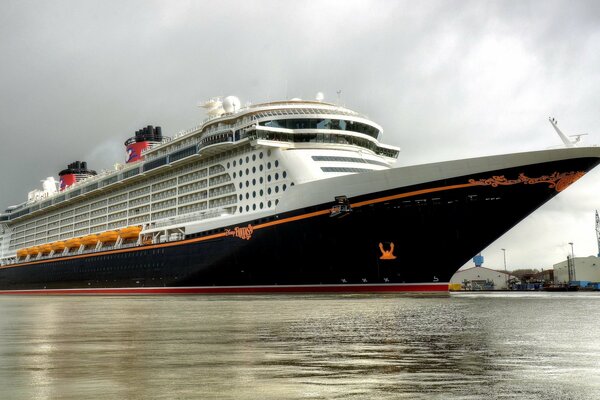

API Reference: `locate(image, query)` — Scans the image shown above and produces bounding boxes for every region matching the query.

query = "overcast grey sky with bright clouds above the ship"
[0,0,600,270]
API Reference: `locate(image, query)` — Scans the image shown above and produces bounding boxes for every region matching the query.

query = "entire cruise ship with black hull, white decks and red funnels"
[0,96,600,295]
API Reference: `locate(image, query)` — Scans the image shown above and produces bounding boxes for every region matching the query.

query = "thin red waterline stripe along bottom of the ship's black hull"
[0,283,448,295]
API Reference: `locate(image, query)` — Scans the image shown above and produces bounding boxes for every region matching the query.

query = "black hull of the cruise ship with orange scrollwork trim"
[0,157,599,294]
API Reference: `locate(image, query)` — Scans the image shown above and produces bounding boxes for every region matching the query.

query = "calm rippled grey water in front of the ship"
[0,293,600,400]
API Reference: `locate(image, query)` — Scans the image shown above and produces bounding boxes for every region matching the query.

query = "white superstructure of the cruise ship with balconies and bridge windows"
[0,96,399,263]
